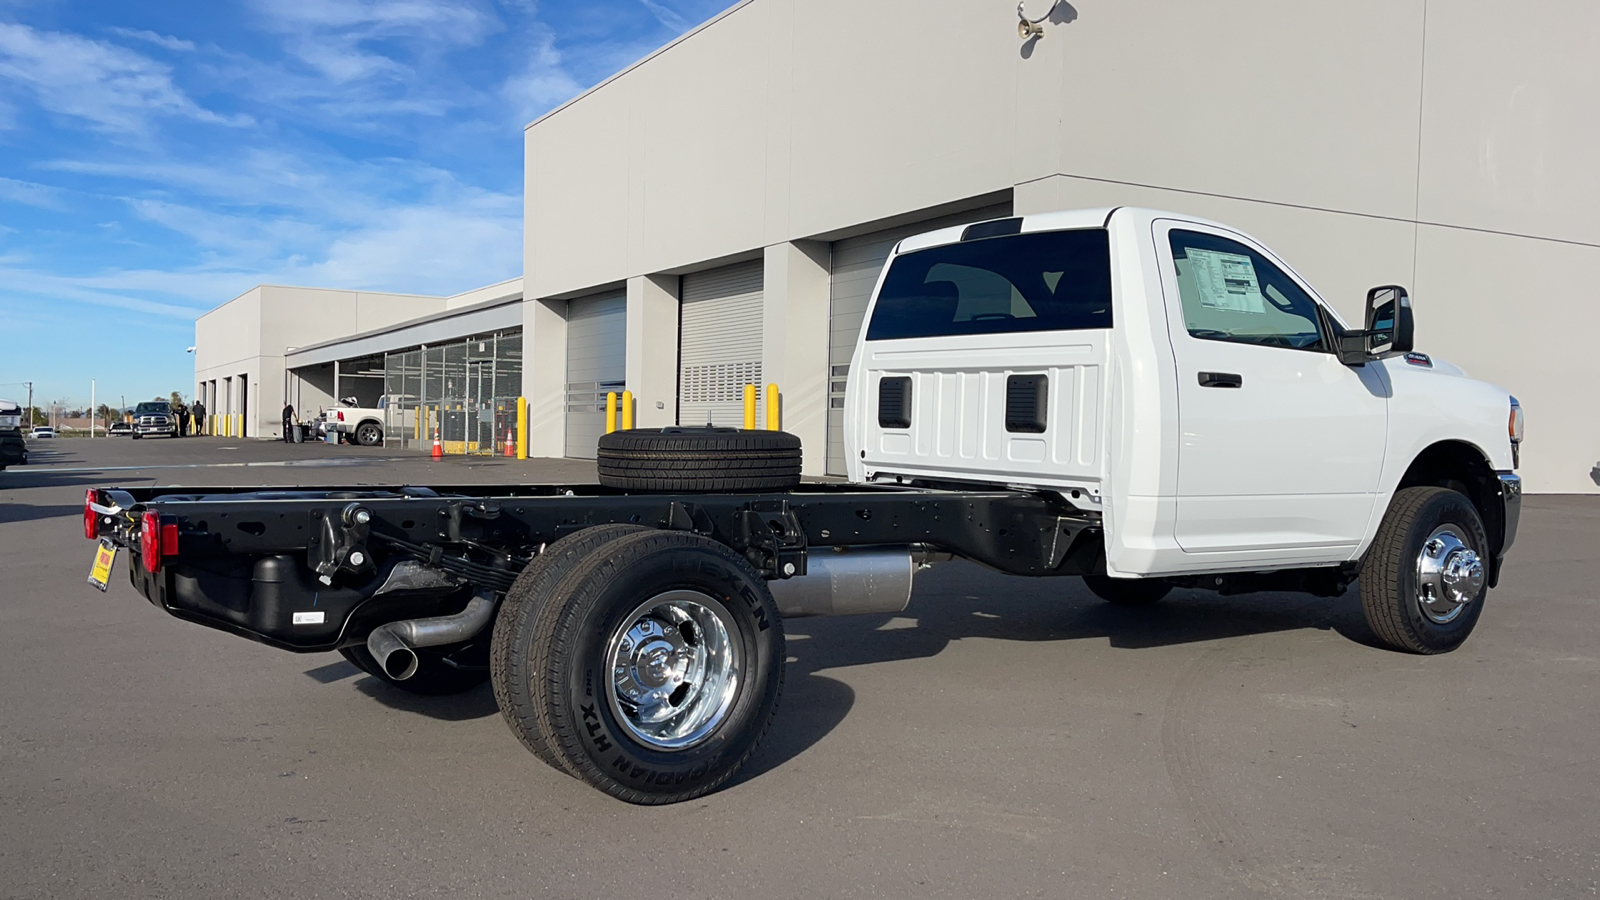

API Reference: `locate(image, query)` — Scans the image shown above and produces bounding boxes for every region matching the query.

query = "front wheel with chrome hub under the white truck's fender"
[1362,487,1490,653]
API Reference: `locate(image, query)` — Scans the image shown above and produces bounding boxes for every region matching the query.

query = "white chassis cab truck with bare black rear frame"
[83,208,1523,804]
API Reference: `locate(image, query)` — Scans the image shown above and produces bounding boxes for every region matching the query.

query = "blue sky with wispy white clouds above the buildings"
[0,0,731,404]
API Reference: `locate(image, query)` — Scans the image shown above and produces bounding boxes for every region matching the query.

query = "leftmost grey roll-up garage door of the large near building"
[566,291,627,460]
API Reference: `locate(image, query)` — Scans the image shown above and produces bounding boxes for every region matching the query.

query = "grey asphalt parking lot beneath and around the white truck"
[0,439,1600,898]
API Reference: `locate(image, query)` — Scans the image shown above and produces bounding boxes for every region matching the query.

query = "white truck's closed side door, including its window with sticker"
[1154,221,1389,564]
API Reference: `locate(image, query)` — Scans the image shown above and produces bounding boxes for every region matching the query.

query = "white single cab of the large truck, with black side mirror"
[845,208,1522,583]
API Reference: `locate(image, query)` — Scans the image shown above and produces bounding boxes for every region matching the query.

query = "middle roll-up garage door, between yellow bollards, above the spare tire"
[678,259,762,428]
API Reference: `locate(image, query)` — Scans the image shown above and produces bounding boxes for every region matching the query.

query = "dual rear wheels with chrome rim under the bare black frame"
[496,530,784,804]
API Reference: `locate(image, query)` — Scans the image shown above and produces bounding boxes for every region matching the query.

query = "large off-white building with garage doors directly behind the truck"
[197,0,1600,492]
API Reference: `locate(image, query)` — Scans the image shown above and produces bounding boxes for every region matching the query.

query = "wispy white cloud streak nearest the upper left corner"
[0,22,251,133]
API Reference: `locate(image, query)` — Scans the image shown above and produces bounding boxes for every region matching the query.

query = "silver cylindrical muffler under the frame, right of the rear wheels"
[766,544,949,618]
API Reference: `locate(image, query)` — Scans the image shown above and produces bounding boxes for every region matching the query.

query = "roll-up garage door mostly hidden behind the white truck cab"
[827,203,1011,476]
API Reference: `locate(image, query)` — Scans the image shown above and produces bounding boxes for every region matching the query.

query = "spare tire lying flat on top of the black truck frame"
[597,426,800,493]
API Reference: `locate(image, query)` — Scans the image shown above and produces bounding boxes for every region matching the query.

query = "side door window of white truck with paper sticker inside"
[1168,229,1328,351]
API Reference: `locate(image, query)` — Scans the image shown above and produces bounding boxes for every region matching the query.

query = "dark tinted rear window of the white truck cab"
[867,229,1110,341]
